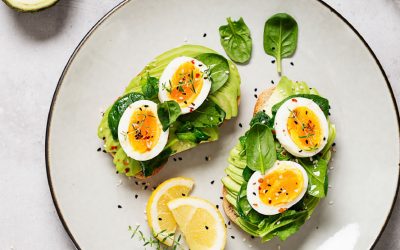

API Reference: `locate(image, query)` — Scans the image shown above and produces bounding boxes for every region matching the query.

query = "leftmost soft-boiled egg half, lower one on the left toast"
[118,100,169,161]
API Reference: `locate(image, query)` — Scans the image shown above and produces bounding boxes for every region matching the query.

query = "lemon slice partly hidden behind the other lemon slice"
[146,177,194,246]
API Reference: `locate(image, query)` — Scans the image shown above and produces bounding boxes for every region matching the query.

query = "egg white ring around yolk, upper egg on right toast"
[274,97,329,157]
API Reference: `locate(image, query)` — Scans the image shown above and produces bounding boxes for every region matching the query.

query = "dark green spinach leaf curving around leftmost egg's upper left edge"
[108,92,144,141]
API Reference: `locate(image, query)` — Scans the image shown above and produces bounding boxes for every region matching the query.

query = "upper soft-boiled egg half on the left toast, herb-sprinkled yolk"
[158,56,211,114]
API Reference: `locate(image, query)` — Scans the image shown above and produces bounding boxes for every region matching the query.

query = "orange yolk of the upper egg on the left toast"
[169,61,203,107]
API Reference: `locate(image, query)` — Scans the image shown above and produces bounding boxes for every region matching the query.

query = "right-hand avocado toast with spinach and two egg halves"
[222,77,336,242]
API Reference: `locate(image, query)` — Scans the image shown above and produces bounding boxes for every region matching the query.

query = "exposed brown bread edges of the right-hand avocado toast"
[222,86,275,224]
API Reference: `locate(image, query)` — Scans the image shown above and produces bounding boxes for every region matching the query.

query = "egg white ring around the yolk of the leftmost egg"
[118,100,169,161]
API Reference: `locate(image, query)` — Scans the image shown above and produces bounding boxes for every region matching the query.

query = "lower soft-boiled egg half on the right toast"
[247,161,308,215]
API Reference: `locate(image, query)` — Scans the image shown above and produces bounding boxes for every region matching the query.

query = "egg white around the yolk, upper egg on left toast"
[158,56,211,114]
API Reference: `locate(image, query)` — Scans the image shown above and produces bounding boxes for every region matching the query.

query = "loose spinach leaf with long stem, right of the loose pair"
[264,13,298,74]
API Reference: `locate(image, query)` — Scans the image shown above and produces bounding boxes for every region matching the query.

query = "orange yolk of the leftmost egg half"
[128,105,161,153]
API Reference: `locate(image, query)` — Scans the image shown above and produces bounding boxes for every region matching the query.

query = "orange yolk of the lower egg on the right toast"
[258,167,304,207]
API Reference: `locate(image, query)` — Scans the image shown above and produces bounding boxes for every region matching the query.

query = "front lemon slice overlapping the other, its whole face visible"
[168,197,226,250]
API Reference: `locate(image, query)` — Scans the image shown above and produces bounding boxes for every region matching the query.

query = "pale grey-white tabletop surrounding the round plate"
[0,0,400,250]
